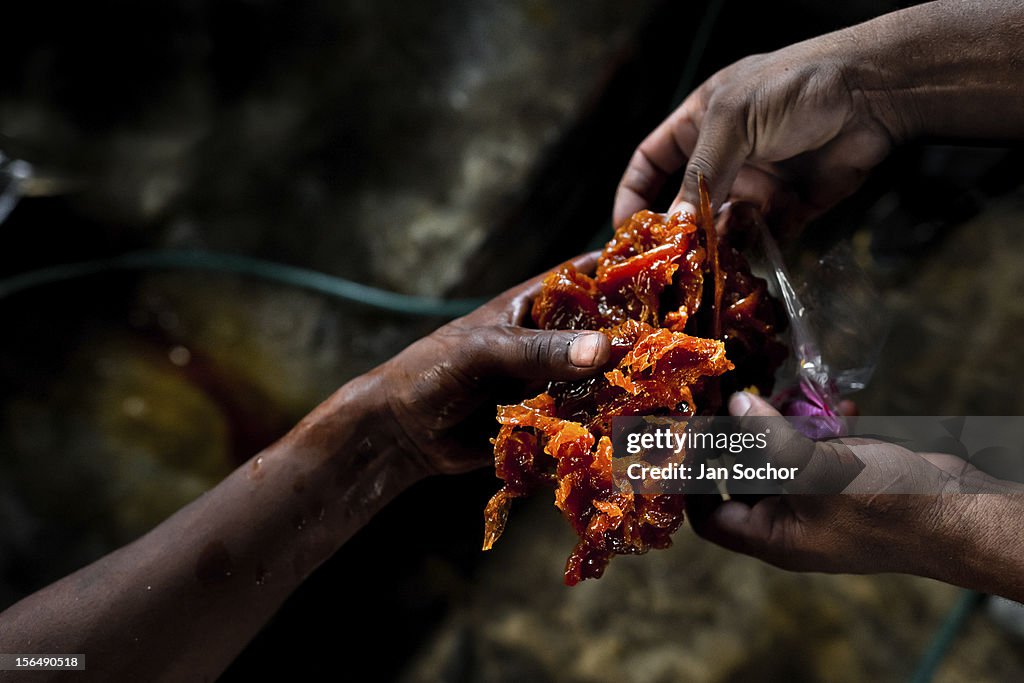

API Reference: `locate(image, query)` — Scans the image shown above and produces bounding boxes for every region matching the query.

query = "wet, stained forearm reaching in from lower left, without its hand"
[0,375,425,680]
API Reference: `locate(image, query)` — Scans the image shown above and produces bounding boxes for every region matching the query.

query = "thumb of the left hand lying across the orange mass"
[475,327,611,380]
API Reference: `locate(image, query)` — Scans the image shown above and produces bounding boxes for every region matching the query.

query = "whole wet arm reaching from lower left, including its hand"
[0,253,609,681]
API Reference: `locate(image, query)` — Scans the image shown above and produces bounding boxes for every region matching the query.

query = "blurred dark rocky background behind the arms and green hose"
[0,0,1024,682]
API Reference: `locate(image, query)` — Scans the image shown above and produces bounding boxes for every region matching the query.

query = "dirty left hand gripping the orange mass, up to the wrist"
[374,253,611,473]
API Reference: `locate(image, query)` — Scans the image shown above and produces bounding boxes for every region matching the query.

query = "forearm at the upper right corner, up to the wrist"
[835,0,1024,141]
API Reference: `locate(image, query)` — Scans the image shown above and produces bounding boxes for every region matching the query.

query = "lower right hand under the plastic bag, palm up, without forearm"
[687,393,1010,584]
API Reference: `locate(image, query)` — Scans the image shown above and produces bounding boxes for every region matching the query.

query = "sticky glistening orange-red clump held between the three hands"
[483,194,785,586]
